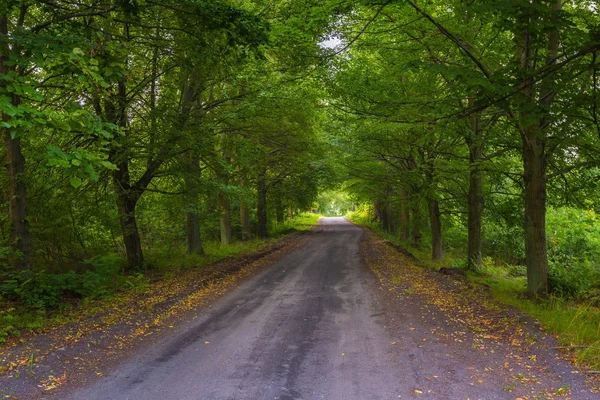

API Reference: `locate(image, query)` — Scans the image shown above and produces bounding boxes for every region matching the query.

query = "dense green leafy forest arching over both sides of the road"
[0,0,600,338]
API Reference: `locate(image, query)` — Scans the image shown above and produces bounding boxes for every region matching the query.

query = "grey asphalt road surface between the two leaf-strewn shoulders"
[65,218,406,400]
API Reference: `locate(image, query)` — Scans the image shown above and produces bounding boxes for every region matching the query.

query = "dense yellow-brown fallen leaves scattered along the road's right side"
[361,232,597,400]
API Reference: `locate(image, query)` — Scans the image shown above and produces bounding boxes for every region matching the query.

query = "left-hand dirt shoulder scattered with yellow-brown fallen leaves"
[0,232,309,399]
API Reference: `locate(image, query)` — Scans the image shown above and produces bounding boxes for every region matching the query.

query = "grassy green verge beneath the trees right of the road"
[348,213,600,370]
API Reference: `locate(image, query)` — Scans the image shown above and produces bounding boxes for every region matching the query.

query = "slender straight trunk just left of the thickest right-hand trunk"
[467,98,483,270]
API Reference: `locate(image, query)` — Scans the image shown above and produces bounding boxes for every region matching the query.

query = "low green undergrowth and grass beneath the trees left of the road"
[0,213,320,343]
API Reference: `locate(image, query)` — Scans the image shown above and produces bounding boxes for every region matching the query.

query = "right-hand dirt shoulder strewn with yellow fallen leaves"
[361,230,599,399]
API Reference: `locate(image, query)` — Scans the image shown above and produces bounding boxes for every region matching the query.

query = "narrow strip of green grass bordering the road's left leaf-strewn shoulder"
[0,213,319,345]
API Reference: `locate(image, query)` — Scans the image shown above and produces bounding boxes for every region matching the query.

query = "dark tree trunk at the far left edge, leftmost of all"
[0,14,31,271]
